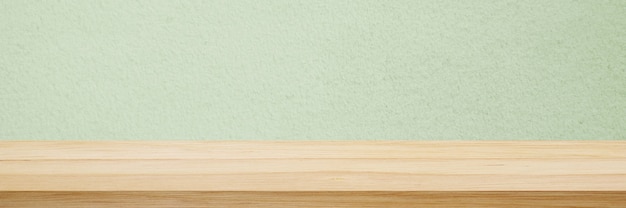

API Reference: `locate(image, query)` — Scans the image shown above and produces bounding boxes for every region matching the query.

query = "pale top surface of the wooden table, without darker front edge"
[0,141,626,191]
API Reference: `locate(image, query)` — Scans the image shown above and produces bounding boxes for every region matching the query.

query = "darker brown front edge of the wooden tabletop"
[0,191,626,208]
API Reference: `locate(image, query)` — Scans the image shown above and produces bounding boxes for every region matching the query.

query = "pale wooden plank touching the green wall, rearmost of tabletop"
[0,141,626,160]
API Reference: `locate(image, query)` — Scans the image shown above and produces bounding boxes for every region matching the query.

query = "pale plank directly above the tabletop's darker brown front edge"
[0,173,626,191]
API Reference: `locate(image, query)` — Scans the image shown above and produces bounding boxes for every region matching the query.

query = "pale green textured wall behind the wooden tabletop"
[0,0,626,140]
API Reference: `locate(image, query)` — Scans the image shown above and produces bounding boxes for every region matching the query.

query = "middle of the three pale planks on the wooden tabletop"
[0,158,626,176]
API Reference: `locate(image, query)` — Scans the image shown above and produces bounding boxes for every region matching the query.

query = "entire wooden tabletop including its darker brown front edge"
[0,141,626,207]
